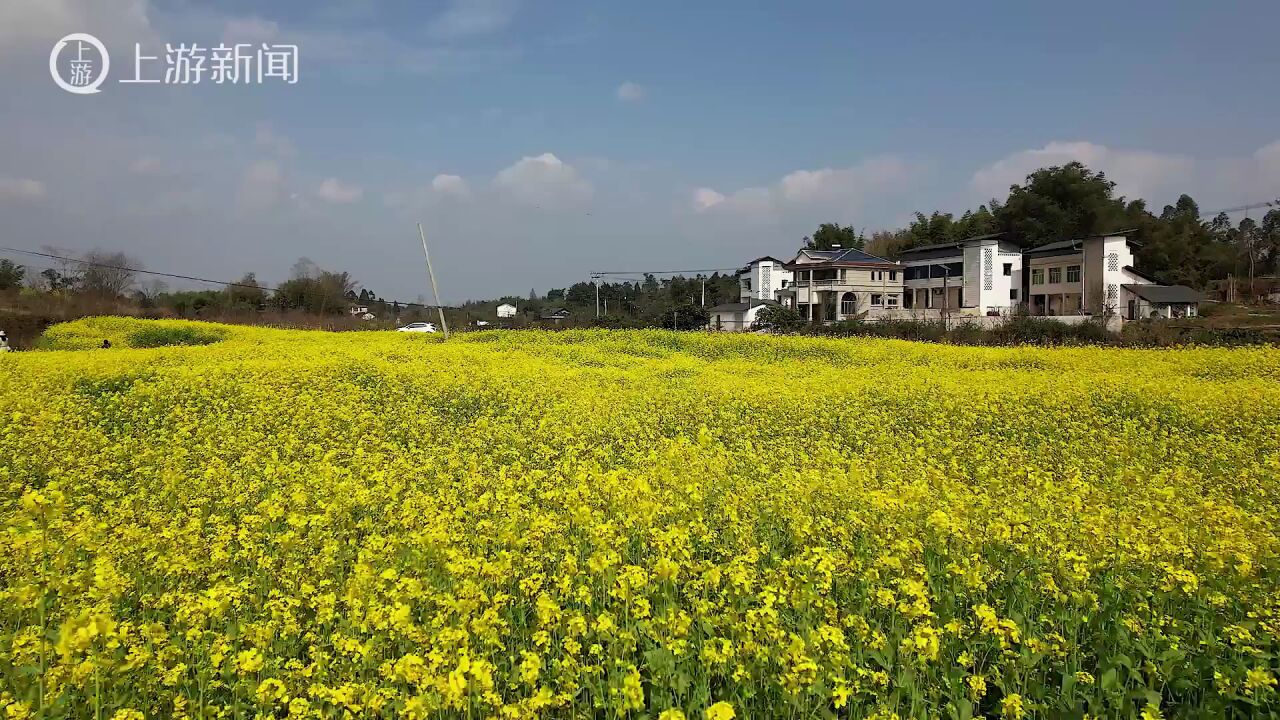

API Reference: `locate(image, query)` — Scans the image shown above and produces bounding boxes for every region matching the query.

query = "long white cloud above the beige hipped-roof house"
[692,158,915,214]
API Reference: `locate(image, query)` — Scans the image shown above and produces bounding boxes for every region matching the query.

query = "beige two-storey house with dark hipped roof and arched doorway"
[777,247,902,323]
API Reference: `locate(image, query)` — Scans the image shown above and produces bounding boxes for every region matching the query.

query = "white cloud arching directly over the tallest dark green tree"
[972,141,1194,202]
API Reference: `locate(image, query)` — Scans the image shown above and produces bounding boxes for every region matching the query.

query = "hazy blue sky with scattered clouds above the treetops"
[0,0,1280,301]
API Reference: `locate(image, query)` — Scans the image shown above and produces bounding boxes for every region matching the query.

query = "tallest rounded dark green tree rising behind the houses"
[993,163,1128,247]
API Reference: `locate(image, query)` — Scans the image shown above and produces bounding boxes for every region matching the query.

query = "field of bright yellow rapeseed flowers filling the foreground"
[0,319,1280,720]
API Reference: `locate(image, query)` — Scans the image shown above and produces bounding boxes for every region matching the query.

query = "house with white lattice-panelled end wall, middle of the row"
[897,233,1023,315]
